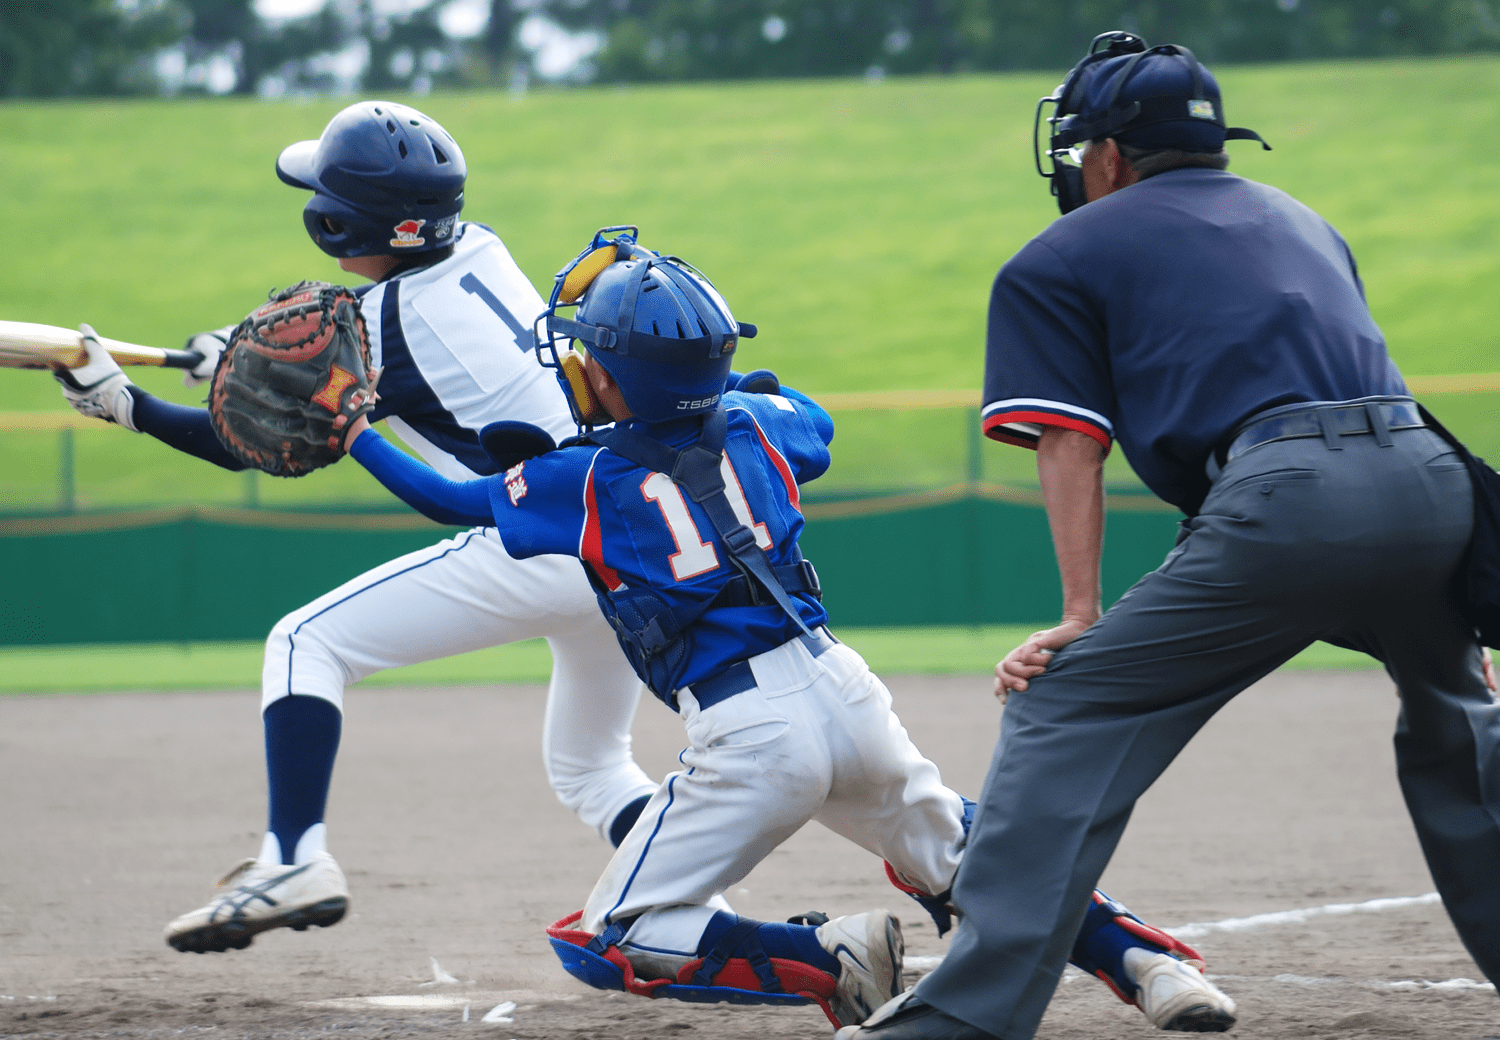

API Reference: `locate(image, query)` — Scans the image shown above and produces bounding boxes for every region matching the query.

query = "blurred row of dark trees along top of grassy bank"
[0,0,1500,98]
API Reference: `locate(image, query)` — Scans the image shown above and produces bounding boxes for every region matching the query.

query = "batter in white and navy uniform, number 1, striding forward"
[51,101,657,953]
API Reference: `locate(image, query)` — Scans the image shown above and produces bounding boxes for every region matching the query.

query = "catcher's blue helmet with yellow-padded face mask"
[537,227,756,425]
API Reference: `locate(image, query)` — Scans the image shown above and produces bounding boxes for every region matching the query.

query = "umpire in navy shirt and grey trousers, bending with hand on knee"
[840,33,1500,1040]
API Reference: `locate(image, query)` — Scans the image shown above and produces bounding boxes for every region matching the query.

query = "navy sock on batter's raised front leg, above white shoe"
[261,696,344,863]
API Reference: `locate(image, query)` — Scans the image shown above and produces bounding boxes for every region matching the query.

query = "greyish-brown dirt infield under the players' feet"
[0,672,1500,1040]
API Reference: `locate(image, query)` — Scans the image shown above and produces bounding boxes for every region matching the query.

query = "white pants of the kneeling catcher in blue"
[581,639,963,974]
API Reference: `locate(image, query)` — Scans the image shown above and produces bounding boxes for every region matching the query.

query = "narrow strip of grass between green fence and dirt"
[0,624,1379,695]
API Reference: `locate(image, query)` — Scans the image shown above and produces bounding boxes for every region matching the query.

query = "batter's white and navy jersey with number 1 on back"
[360,222,575,480]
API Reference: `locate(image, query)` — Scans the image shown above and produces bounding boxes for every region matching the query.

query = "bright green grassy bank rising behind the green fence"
[0,57,1500,512]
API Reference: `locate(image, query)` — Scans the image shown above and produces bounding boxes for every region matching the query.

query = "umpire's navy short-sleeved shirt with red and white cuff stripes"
[983,167,1407,516]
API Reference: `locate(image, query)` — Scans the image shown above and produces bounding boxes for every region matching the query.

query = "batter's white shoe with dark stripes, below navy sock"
[167,852,350,953]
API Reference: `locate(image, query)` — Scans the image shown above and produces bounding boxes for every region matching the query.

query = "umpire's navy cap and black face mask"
[1032,32,1271,213]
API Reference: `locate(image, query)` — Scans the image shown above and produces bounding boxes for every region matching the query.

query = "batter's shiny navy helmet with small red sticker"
[276,101,468,258]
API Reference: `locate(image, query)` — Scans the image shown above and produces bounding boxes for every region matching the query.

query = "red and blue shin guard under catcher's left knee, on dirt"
[548,911,843,1029]
